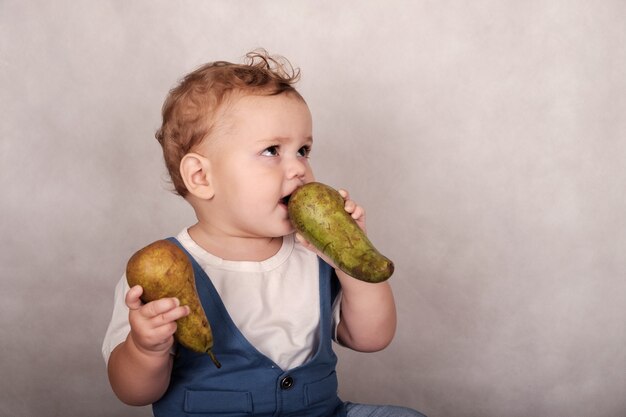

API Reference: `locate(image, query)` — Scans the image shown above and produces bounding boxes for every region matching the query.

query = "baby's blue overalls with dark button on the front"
[153,238,346,417]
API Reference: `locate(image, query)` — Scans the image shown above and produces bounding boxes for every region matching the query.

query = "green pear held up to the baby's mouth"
[287,182,394,283]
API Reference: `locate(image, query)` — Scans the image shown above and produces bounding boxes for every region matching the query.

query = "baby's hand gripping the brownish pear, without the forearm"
[126,285,190,353]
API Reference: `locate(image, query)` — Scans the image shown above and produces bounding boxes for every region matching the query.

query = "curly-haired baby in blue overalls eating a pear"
[103,51,422,417]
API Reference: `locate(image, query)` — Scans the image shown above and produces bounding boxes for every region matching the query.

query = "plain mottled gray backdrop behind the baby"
[0,0,626,417]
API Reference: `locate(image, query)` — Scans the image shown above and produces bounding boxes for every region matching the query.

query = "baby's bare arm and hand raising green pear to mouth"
[298,190,396,352]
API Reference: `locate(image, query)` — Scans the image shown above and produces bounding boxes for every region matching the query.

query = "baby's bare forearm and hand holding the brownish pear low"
[108,286,189,405]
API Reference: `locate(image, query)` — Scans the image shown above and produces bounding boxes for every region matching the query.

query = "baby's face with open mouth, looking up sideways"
[200,94,314,237]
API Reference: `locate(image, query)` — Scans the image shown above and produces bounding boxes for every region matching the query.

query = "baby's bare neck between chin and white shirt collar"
[188,223,283,262]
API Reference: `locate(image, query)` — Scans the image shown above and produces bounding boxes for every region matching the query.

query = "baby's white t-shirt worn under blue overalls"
[102,229,341,370]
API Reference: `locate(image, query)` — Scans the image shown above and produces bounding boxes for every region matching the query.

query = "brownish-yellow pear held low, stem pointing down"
[126,240,221,368]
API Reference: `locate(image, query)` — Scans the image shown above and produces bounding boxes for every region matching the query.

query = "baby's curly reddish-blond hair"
[155,49,302,197]
